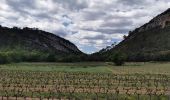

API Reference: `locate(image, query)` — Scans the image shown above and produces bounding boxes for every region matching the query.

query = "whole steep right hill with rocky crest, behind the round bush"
[97,9,170,61]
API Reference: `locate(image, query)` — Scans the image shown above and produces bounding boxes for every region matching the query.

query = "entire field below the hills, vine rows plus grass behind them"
[0,62,170,100]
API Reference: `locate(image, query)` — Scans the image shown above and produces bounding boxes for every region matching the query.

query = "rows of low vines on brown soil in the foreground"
[0,62,170,100]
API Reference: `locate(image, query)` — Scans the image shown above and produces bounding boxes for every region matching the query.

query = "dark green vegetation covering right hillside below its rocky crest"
[94,23,170,62]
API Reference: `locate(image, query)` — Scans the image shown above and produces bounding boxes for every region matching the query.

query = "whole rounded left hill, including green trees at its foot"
[0,26,83,62]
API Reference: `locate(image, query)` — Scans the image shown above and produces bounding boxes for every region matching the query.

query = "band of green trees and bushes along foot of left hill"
[0,47,84,64]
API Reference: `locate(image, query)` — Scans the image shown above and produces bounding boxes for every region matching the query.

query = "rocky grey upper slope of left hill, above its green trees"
[0,27,81,53]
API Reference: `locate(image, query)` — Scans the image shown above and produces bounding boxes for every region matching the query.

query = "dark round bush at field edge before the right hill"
[112,52,126,66]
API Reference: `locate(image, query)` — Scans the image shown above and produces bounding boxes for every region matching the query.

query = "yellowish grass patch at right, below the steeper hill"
[109,62,170,75]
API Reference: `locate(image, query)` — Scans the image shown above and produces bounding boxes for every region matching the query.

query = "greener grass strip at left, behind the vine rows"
[0,63,111,73]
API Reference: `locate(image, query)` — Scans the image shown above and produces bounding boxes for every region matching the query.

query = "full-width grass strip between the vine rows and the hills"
[0,62,170,75]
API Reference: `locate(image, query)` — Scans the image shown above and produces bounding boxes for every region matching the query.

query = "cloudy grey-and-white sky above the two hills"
[0,0,170,53]
